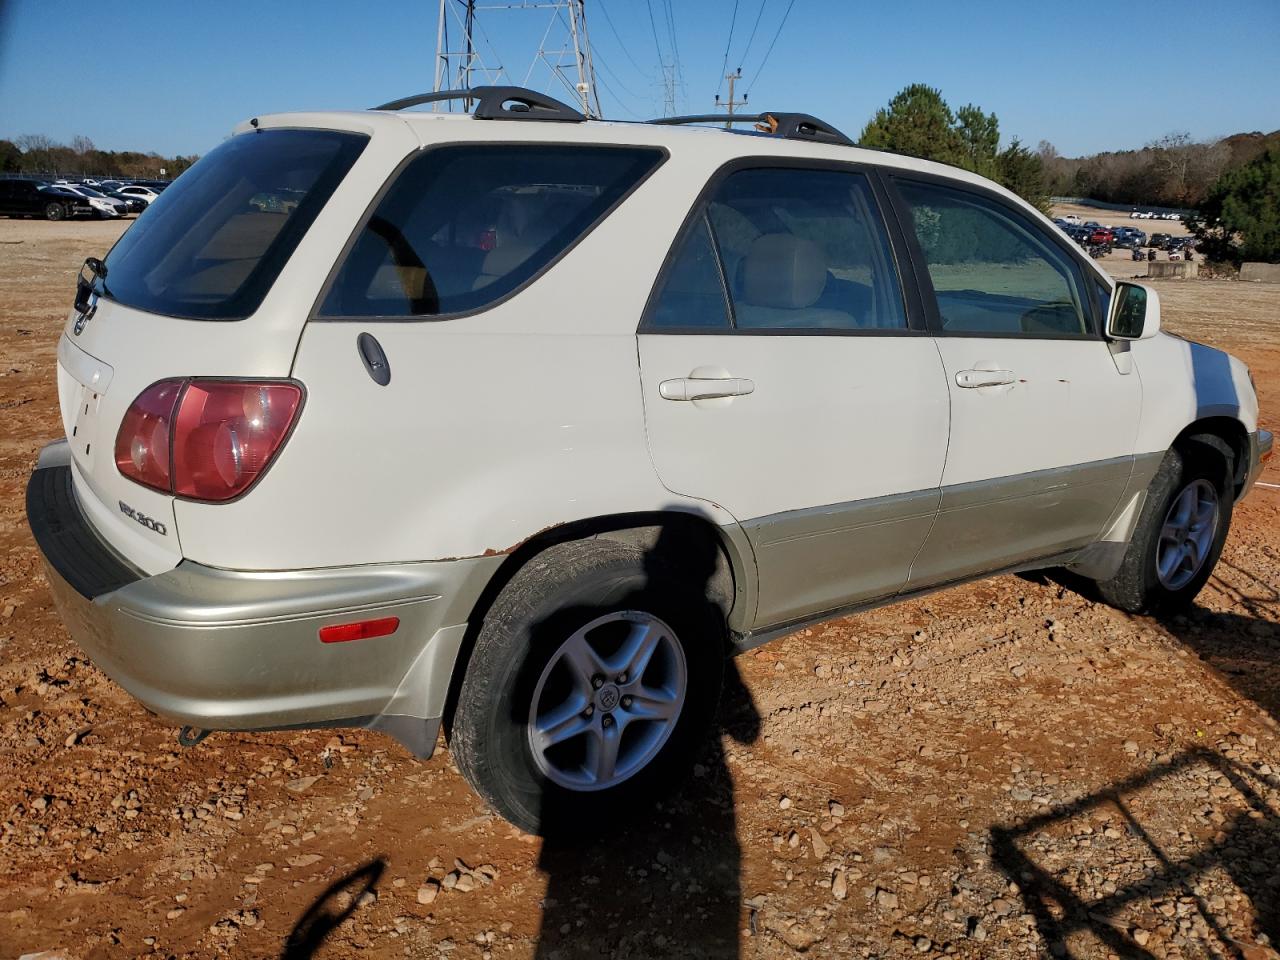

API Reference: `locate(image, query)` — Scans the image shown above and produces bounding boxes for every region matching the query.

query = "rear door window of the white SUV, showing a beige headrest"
[645,168,906,332]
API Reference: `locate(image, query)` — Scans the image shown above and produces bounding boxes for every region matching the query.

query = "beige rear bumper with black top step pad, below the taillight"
[27,442,500,755]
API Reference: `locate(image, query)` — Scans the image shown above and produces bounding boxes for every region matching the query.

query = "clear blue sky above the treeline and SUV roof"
[0,0,1280,156]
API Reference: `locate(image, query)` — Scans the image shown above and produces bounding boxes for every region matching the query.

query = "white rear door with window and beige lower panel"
[639,160,947,627]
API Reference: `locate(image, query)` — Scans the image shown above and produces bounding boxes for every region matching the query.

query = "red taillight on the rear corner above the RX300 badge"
[115,380,302,502]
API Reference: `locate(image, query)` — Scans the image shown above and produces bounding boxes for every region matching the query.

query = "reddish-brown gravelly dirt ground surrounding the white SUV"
[0,221,1280,960]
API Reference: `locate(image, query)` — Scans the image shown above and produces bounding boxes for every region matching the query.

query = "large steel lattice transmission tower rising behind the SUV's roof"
[433,0,600,116]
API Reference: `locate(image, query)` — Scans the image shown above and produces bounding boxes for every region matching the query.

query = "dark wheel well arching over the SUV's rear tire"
[444,511,742,736]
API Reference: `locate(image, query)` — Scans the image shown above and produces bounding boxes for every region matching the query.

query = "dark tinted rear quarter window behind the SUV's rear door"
[320,145,663,317]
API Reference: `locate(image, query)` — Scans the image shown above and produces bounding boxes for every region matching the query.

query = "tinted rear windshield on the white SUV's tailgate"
[100,131,367,320]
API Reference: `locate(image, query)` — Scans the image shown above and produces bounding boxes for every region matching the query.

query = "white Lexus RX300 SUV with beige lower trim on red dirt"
[28,88,1271,832]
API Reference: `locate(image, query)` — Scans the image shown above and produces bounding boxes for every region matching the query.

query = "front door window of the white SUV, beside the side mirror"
[897,182,1091,337]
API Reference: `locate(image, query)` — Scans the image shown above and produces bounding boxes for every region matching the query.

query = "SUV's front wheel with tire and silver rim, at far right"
[1098,443,1234,614]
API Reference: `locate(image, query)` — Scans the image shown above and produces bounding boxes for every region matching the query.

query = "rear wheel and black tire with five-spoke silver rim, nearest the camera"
[449,539,726,837]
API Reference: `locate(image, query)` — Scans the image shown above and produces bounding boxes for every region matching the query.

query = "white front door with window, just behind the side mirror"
[891,177,1142,588]
